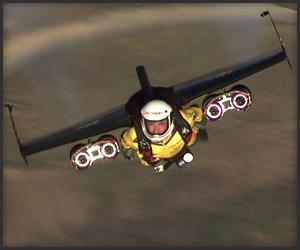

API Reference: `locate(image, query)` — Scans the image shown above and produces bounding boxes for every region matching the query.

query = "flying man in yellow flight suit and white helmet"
[121,99,207,173]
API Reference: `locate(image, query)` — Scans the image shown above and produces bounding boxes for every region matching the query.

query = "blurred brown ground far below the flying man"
[3,4,297,246]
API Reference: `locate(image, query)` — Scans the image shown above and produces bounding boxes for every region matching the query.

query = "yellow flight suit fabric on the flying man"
[121,106,203,166]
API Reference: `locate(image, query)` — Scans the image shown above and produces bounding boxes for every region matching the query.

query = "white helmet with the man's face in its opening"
[141,100,174,143]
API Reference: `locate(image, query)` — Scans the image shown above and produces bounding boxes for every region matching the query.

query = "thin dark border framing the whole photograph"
[0,0,300,250]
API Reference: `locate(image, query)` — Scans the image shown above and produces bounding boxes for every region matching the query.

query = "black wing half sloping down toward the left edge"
[19,105,131,158]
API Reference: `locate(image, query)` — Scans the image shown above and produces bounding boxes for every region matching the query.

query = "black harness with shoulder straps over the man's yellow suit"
[126,87,192,165]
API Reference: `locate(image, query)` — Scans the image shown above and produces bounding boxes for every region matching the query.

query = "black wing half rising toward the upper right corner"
[173,46,287,105]
